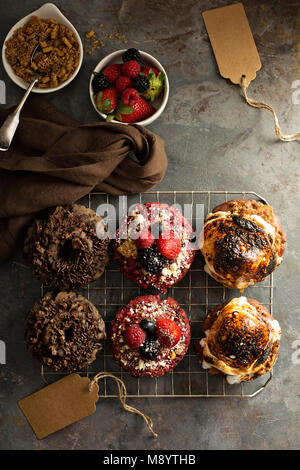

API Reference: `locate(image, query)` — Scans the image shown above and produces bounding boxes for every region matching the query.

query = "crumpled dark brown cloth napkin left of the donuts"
[0,95,167,262]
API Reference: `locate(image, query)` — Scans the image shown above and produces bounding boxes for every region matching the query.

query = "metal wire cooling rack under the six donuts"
[41,191,273,398]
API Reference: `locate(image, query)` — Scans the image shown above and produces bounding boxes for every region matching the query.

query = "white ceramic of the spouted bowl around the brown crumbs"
[2,3,83,93]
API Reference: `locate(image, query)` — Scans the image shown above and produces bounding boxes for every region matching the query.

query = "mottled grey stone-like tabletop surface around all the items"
[0,0,300,450]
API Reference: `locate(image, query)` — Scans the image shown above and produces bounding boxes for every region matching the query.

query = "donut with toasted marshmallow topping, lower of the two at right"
[195,297,281,384]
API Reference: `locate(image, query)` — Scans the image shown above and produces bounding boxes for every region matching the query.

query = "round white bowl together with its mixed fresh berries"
[89,48,169,126]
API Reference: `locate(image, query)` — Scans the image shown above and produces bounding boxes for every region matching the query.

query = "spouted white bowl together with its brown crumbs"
[2,3,83,93]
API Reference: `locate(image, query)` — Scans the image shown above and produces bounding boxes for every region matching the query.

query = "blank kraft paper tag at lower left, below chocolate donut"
[18,374,99,439]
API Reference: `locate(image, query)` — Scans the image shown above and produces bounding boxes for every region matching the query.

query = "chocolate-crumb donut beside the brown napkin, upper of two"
[24,204,109,290]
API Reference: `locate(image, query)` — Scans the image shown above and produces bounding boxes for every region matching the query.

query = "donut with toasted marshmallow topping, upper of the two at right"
[199,199,286,291]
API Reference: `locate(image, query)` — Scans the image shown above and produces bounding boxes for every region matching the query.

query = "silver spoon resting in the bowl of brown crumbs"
[0,44,43,152]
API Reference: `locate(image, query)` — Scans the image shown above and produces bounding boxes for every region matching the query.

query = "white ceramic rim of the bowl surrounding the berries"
[89,49,169,126]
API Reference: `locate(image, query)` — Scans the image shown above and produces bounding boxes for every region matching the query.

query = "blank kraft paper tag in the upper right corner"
[202,3,261,87]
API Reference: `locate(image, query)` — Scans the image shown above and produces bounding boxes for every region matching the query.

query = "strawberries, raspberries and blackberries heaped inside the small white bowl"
[92,48,165,123]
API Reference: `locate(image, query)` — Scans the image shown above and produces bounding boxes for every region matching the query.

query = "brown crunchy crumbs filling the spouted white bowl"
[5,16,80,88]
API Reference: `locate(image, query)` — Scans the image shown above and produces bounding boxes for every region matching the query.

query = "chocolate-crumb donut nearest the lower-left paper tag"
[25,292,106,371]
